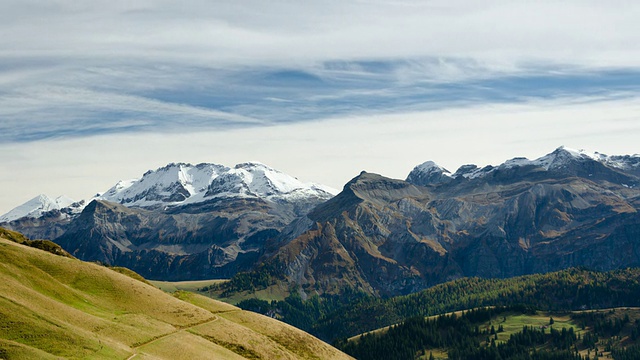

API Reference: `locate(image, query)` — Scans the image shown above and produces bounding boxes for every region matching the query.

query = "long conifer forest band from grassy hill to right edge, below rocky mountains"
[238,268,640,342]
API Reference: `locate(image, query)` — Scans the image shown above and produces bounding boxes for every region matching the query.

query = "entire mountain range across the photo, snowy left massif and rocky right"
[0,147,640,296]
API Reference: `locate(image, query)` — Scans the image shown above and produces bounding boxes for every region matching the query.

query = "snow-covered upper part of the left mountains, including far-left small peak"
[0,162,337,239]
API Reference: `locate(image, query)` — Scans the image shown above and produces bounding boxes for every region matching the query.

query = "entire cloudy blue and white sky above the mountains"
[0,0,640,214]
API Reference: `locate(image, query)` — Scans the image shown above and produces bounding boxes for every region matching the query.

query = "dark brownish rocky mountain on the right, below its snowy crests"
[272,159,640,296]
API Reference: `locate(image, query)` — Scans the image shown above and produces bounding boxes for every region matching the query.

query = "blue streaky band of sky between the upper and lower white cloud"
[0,59,640,142]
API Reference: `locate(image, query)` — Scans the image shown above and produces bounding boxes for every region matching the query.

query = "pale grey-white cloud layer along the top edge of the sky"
[5,0,640,66]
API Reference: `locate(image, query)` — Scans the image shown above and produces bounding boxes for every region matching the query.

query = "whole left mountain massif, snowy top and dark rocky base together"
[4,162,336,280]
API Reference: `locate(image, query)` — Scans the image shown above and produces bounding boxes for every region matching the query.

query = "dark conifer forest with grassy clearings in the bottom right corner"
[336,306,640,360]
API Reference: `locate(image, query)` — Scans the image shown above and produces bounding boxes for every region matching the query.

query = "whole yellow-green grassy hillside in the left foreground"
[0,229,348,359]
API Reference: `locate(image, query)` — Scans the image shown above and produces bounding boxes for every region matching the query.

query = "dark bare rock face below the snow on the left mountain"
[55,198,320,280]
